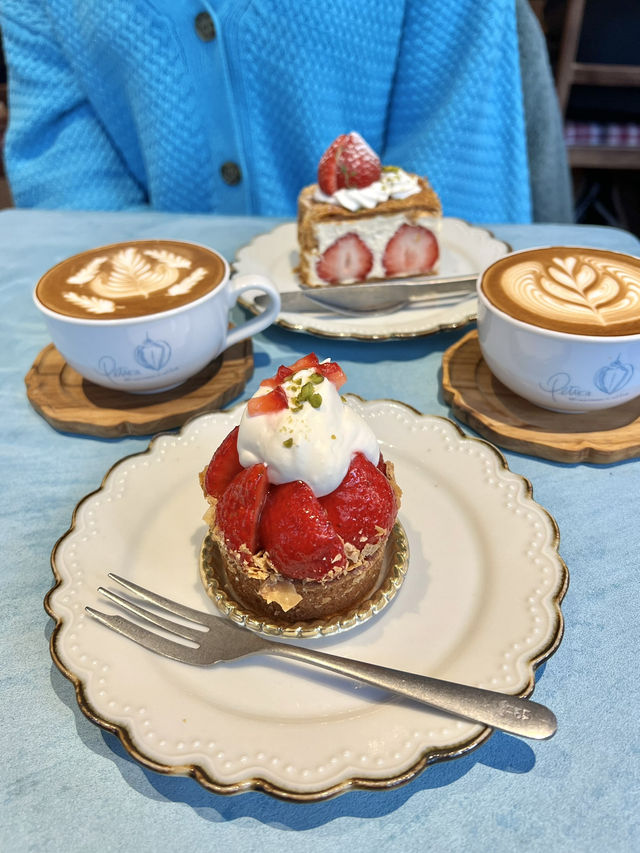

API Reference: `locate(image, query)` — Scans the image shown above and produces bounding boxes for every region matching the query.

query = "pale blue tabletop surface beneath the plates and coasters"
[0,210,640,853]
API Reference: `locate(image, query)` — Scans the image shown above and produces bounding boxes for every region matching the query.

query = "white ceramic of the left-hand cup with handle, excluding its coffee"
[34,242,280,394]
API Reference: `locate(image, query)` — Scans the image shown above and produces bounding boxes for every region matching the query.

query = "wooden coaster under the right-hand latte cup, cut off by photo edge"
[442,330,640,464]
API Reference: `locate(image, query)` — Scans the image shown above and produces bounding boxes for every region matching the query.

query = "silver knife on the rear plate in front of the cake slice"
[254,275,477,314]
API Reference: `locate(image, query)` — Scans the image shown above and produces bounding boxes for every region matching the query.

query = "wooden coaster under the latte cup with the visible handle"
[25,340,253,438]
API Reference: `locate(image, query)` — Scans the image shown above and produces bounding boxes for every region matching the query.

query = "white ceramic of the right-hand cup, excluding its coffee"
[477,249,640,413]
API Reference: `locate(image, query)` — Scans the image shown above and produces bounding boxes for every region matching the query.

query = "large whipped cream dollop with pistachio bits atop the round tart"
[238,368,380,498]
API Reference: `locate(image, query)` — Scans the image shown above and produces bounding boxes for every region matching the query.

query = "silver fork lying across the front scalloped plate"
[85,573,557,740]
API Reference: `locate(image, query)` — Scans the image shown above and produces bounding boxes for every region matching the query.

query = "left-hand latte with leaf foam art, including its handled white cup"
[33,240,280,394]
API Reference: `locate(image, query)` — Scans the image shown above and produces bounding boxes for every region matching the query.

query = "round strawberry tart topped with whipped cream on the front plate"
[200,354,400,624]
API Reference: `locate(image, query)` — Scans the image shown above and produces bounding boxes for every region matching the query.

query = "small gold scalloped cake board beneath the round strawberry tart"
[200,522,409,640]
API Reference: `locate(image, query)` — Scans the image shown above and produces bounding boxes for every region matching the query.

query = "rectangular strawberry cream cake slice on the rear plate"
[297,133,442,287]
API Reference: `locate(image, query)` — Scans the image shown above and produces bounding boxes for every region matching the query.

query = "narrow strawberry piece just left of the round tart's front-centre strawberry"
[216,463,269,559]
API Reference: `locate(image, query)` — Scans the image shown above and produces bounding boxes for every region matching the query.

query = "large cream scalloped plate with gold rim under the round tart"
[45,395,568,800]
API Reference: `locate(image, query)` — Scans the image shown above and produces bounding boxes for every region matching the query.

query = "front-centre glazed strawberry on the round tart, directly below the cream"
[259,480,346,580]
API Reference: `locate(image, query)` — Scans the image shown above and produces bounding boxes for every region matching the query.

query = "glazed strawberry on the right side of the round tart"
[320,453,398,550]
